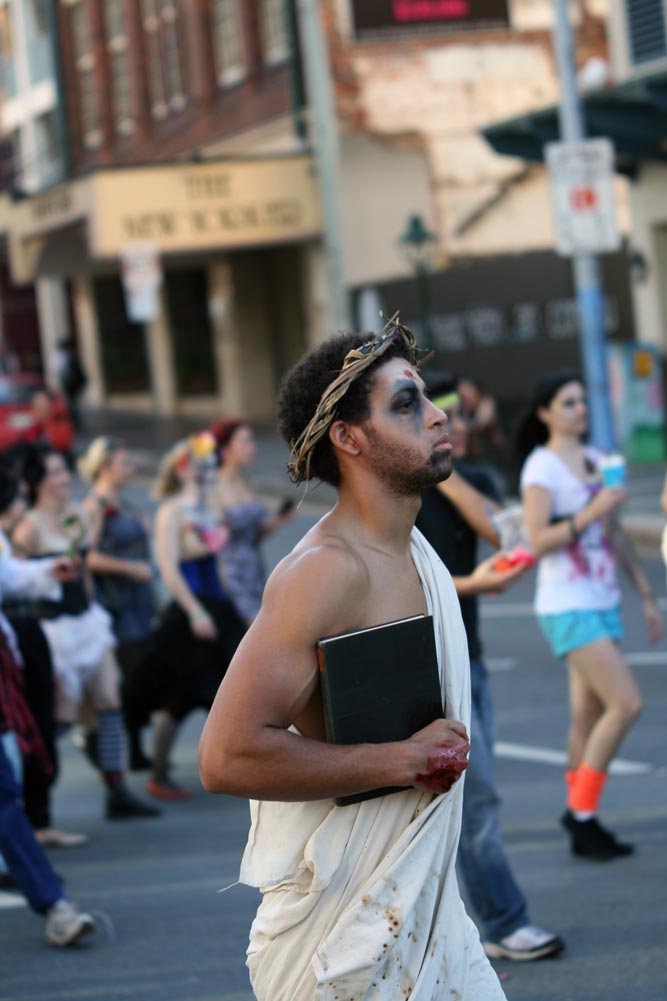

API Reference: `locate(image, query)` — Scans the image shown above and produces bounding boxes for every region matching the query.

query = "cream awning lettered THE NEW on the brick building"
[0,154,321,282]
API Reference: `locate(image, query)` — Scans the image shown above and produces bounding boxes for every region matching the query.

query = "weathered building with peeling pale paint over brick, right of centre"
[325,0,633,420]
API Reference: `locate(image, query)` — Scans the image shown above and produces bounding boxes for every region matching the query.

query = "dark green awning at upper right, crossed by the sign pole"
[481,72,667,175]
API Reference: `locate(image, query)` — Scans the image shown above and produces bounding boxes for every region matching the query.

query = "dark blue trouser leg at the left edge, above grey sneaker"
[0,728,63,914]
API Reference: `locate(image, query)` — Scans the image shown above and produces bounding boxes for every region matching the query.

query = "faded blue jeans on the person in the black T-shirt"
[459,661,529,942]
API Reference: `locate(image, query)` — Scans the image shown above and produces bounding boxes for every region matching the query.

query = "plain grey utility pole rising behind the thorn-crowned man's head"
[296,0,351,330]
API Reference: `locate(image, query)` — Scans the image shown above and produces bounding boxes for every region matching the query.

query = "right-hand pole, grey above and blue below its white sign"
[554,0,616,451]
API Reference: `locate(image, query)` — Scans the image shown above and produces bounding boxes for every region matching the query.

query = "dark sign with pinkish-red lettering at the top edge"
[352,0,509,38]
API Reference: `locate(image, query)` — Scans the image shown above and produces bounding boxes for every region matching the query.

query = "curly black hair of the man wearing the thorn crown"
[276,332,416,486]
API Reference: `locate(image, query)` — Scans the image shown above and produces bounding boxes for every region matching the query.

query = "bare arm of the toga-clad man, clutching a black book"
[199,546,465,801]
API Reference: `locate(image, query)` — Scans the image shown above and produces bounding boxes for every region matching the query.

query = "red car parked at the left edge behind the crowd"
[0,372,74,452]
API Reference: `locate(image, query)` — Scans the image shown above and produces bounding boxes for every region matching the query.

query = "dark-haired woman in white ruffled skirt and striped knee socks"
[12,448,158,820]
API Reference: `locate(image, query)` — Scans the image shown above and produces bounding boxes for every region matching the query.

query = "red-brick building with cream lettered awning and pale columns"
[4,0,325,420]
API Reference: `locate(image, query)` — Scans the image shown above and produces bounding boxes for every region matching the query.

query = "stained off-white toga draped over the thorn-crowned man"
[236,530,505,1001]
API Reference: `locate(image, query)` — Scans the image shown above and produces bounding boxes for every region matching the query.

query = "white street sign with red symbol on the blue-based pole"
[546,139,621,257]
